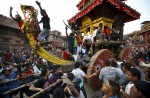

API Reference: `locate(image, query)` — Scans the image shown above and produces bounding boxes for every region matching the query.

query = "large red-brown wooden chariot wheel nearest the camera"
[87,49,114,91]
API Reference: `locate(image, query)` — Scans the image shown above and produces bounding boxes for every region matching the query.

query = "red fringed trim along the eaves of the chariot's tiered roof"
[69,0,140,23]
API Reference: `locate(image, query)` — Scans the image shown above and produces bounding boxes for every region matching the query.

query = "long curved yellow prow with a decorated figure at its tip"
[21,5,74,65]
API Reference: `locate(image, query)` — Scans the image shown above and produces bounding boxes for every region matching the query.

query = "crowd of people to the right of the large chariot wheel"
[99,47,150,98]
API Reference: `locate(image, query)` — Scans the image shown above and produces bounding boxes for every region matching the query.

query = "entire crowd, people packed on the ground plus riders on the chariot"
[0,1,150,98]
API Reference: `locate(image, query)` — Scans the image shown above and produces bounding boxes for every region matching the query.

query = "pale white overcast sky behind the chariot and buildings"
[0,0,150,35]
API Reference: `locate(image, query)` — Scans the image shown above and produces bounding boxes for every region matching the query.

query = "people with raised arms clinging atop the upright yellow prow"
[10,1,51,44]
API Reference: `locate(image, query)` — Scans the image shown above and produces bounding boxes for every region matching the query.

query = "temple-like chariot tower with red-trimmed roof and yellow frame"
[69,0,140,91]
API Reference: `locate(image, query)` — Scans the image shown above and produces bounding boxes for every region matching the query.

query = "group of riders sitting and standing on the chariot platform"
[65,23,120,60]
